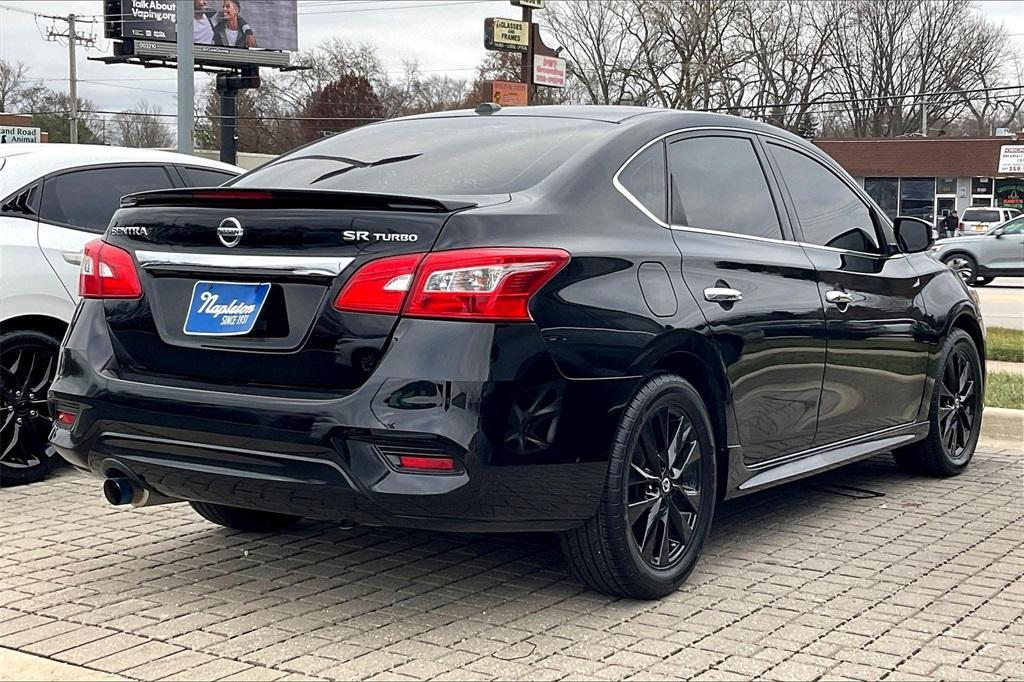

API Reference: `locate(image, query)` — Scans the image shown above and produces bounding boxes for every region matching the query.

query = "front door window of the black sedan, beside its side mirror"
[770,144,882,253]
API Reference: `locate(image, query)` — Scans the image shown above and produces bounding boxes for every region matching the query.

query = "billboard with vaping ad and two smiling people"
[105,0,299,63]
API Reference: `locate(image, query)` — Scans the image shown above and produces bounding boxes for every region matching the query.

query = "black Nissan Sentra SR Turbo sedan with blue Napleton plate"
[50,104,985,598]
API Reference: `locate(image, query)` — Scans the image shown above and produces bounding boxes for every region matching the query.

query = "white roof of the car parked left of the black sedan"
[0,143,243,191]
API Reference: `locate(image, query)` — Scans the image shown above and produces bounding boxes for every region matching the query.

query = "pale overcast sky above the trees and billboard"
[0,0,1024,119]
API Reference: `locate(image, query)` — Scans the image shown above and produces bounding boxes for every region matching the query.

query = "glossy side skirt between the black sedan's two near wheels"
[725,422,929,500]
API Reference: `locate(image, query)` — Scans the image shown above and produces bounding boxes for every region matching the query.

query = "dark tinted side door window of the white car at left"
[39,166,172,232]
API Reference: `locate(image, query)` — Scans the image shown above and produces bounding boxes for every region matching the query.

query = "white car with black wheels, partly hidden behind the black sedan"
[0,144,242,485]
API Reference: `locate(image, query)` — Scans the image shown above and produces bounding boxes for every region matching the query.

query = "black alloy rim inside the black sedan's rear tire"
[626,406,702,568]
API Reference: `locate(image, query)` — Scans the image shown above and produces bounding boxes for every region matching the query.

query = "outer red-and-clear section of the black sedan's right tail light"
[403,249,569,322]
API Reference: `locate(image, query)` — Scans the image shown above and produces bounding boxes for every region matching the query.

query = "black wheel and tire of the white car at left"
[0,331,62,485]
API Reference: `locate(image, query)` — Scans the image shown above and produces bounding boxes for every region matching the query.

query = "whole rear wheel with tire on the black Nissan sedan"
[561,374,717,599]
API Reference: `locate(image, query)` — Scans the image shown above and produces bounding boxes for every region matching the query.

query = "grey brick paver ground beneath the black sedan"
[0,442,1024,680]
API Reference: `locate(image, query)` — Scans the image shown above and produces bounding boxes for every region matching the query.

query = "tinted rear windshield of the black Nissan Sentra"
[232,116,611,196]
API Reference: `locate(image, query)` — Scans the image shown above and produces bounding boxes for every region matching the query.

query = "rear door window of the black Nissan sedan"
[669,137,782,239]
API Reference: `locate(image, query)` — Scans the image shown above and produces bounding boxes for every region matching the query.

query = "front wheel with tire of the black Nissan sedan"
[893,329,985,476]
